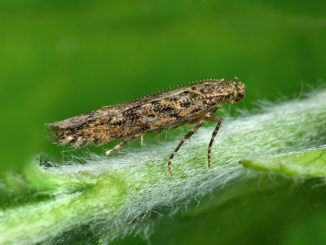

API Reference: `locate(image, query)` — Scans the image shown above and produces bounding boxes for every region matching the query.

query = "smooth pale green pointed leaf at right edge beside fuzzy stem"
[240,147,326,177]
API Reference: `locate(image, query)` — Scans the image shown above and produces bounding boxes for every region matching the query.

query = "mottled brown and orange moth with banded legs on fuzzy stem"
[47,77,245,175]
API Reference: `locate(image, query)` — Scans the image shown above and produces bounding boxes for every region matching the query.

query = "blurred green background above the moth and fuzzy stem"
[0,0,326,172]
